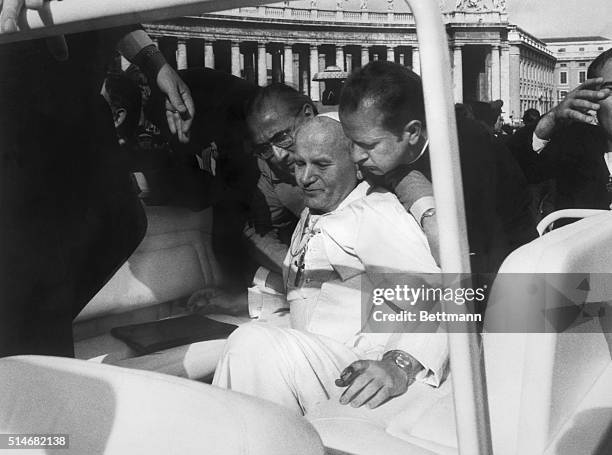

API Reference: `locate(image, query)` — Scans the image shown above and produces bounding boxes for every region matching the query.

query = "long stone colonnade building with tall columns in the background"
[139,0,554,120]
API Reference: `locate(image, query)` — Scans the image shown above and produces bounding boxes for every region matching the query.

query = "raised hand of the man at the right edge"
[535,77,610,140]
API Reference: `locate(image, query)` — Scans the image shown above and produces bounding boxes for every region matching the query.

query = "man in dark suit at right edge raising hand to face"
[510,50,612,218]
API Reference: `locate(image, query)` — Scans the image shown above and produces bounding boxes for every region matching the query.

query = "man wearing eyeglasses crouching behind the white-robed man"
[245,84,317,291]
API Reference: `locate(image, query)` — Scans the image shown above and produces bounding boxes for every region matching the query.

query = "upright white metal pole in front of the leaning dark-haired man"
[406,0,492,455]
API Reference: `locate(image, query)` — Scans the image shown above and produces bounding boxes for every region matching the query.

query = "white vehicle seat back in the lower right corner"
[484,212,612,455]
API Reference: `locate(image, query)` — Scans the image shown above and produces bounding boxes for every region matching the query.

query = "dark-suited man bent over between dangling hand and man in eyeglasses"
[144,68,259,288]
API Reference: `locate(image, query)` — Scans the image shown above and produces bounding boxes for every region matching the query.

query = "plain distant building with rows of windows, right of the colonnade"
[544,36,612,104]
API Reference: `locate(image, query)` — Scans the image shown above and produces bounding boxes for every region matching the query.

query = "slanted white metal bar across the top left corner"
[0,0,269,44]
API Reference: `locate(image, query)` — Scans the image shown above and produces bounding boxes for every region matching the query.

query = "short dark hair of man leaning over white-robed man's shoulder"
[339,60,425,135]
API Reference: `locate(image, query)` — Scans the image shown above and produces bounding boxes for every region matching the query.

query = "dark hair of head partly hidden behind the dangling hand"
[104,74,142,141]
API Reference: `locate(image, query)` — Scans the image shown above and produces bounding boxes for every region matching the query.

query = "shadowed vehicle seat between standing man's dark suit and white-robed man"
[73,206,230,361]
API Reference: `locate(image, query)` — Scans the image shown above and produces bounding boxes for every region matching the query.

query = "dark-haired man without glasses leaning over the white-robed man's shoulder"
[340,61,536,272]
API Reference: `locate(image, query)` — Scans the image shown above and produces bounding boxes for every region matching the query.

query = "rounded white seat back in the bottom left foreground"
[0,356,323,455]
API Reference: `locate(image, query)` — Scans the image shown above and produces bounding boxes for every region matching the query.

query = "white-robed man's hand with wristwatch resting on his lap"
[336,360,414,409]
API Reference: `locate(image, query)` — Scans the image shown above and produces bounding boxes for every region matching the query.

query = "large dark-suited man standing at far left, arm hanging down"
[0,16,193,356]
